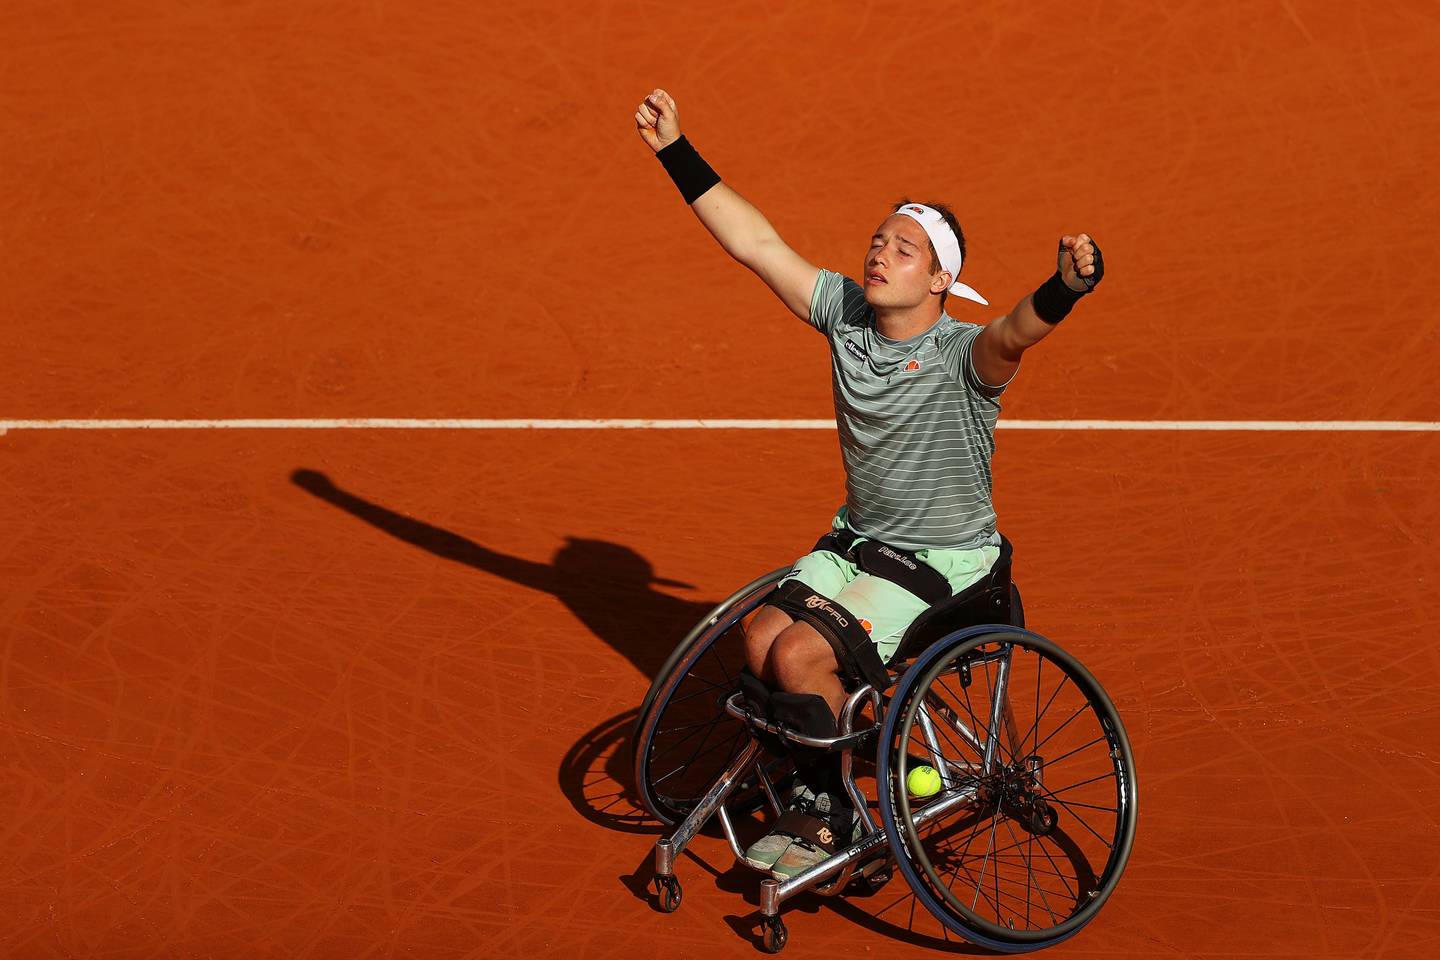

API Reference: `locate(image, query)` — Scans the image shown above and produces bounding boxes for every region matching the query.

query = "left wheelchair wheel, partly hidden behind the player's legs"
[632,567,791,826]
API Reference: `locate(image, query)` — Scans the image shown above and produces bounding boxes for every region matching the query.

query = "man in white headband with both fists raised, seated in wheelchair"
[635,89,1104,879]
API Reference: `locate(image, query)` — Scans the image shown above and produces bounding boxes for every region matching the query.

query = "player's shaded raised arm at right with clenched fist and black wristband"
[971,233,1104,387]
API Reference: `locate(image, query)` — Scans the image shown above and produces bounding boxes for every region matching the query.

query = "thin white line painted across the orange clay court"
[0,417,1440,435]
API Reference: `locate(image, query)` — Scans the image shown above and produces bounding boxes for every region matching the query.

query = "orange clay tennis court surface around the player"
[0,0,1440,960]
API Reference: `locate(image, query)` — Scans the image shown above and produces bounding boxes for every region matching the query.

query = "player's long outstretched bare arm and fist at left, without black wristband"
[635,89,819,321]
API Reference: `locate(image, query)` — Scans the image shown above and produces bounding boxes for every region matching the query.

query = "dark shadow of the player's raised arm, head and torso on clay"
[289,469,711,676]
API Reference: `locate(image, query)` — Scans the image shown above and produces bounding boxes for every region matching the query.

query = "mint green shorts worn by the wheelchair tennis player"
[785,507,999,664]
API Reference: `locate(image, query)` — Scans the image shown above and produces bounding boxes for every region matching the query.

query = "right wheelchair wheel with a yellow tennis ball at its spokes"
[877,625,1136,953]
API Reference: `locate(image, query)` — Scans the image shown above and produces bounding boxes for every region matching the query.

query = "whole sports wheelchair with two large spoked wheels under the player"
[634,541,1136,953]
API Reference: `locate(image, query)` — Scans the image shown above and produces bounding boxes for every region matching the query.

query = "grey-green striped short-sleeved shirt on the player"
[809,271,1005,550]
